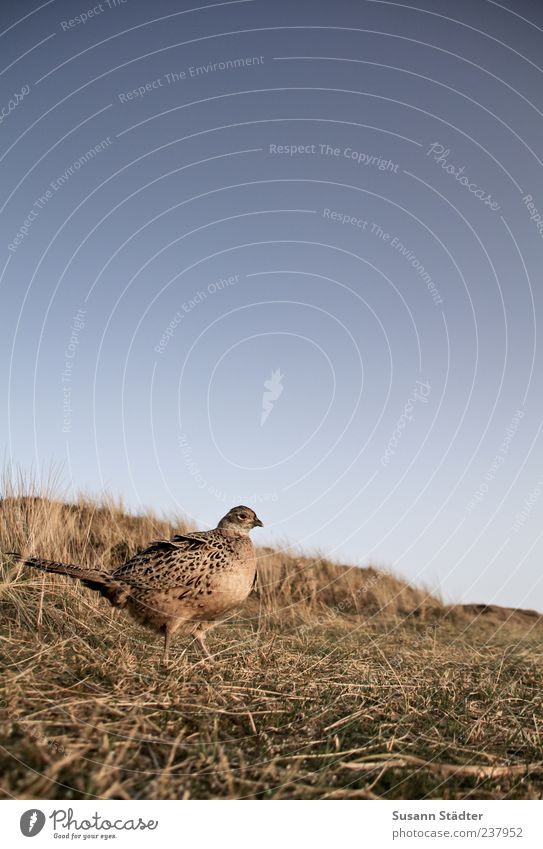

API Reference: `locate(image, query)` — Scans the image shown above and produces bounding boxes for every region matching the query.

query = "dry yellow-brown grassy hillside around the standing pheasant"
[0,496,543,799]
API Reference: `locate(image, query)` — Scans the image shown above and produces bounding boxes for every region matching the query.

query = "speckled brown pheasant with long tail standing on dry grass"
[11,505,264,665]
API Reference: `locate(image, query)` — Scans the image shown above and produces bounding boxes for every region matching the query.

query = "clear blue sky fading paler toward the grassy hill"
[0,0,543,610]
